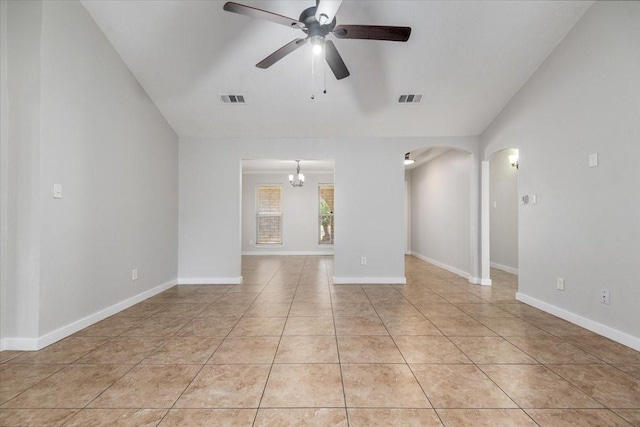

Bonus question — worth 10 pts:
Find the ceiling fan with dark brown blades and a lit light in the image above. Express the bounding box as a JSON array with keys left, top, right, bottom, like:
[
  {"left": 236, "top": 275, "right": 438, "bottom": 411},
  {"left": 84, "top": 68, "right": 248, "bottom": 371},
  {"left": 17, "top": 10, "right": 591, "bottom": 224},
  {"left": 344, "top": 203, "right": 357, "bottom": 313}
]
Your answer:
[{"left": 224, "top": 0, "right": 411, "bottom": 80}]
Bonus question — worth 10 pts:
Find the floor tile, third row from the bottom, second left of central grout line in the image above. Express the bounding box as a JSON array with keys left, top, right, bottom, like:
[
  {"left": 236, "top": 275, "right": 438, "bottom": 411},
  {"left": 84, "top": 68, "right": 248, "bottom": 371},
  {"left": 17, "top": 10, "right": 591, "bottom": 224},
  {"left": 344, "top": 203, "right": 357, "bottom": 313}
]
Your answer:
[{"left": 208, "top": 337, "right": 280, "bottom": 365}]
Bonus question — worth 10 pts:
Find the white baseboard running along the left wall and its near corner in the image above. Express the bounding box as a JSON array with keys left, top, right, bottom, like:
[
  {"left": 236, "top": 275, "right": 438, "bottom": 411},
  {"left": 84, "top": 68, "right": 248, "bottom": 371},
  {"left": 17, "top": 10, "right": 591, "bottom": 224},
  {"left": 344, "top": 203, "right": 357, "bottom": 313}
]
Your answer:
[{"left": 0, "top": 279, "right": 178, "bottom": 350}]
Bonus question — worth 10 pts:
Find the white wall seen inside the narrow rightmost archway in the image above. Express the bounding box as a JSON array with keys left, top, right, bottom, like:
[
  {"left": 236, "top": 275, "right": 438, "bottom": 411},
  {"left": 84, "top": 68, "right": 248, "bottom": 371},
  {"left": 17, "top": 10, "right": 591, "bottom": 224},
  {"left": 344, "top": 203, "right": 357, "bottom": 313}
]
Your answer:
[{"left": 489, "top": 149, "right": 519, "bottom": 274}]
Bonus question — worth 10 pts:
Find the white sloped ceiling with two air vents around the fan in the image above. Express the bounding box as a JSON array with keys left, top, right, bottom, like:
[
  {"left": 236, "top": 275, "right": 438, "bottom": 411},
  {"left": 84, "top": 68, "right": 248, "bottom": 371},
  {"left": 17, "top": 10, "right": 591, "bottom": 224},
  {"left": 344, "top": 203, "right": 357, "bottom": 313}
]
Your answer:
[{"left": 83, "top": 0, "right": 591, "bottom": 137}]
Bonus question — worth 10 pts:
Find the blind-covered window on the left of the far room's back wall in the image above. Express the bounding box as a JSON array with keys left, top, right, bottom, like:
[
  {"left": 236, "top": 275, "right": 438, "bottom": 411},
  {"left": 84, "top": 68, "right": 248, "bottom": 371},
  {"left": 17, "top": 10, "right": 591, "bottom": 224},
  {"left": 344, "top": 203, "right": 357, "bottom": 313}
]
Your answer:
[{"left": 256, "top": 185, "right": 282, "bottom": 245}]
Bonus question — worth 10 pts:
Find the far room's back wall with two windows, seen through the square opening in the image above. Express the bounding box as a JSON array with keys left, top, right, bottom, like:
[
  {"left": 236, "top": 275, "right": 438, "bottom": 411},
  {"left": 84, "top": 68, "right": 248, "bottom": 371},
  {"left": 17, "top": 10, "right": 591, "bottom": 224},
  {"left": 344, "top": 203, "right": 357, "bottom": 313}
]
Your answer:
[{"left": 242, "top": 173, "right": 338, "bottom": 254}]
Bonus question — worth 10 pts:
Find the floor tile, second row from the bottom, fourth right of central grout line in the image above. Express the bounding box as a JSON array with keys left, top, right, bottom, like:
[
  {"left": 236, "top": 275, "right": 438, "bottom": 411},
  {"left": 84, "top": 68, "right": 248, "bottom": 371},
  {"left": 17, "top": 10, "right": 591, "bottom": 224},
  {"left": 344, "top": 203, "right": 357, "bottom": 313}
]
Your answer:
[{"left": 550, "top": 365, "right": 640, "bottom": 409}]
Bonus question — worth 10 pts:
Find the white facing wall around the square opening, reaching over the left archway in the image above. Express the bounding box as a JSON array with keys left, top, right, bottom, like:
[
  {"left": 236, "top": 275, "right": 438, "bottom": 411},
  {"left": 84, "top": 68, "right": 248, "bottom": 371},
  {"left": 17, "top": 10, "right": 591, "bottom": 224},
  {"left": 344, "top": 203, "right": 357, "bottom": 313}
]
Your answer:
[{"left": 179, "top": 137, "right": 478, "bottom": 283}]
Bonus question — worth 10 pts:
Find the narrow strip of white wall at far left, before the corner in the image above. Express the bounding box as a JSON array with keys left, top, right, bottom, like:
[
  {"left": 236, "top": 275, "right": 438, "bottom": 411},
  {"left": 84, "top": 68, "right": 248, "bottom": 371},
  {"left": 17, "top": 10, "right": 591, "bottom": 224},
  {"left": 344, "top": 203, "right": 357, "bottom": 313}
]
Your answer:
[{"left": 0, "top": 2, "right": 42, "bottom": 348}]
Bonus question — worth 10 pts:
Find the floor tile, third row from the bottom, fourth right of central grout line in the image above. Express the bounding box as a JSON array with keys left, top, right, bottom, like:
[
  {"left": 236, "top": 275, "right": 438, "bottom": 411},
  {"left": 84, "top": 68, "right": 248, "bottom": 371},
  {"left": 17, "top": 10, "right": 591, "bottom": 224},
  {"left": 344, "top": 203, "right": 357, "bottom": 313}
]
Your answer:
[{"left": 507, "top": 337, "right": 602, "bottom": 364}]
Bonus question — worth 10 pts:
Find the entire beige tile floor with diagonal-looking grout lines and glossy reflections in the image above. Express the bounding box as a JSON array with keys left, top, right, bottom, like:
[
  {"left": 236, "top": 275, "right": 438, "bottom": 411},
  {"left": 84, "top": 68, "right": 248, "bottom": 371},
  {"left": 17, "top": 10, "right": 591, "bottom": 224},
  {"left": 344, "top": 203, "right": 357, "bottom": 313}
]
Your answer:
[{"left": 0, "top": 257, "right": 640, "bottom": 427}]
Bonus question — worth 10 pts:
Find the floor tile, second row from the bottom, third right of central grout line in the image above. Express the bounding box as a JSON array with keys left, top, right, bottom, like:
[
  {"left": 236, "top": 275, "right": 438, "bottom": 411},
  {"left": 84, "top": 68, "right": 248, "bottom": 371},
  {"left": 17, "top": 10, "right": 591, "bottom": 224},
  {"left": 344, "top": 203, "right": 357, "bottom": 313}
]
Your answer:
[{"left": 480, "top": 365, "right": 602, "bottom": 408}]
